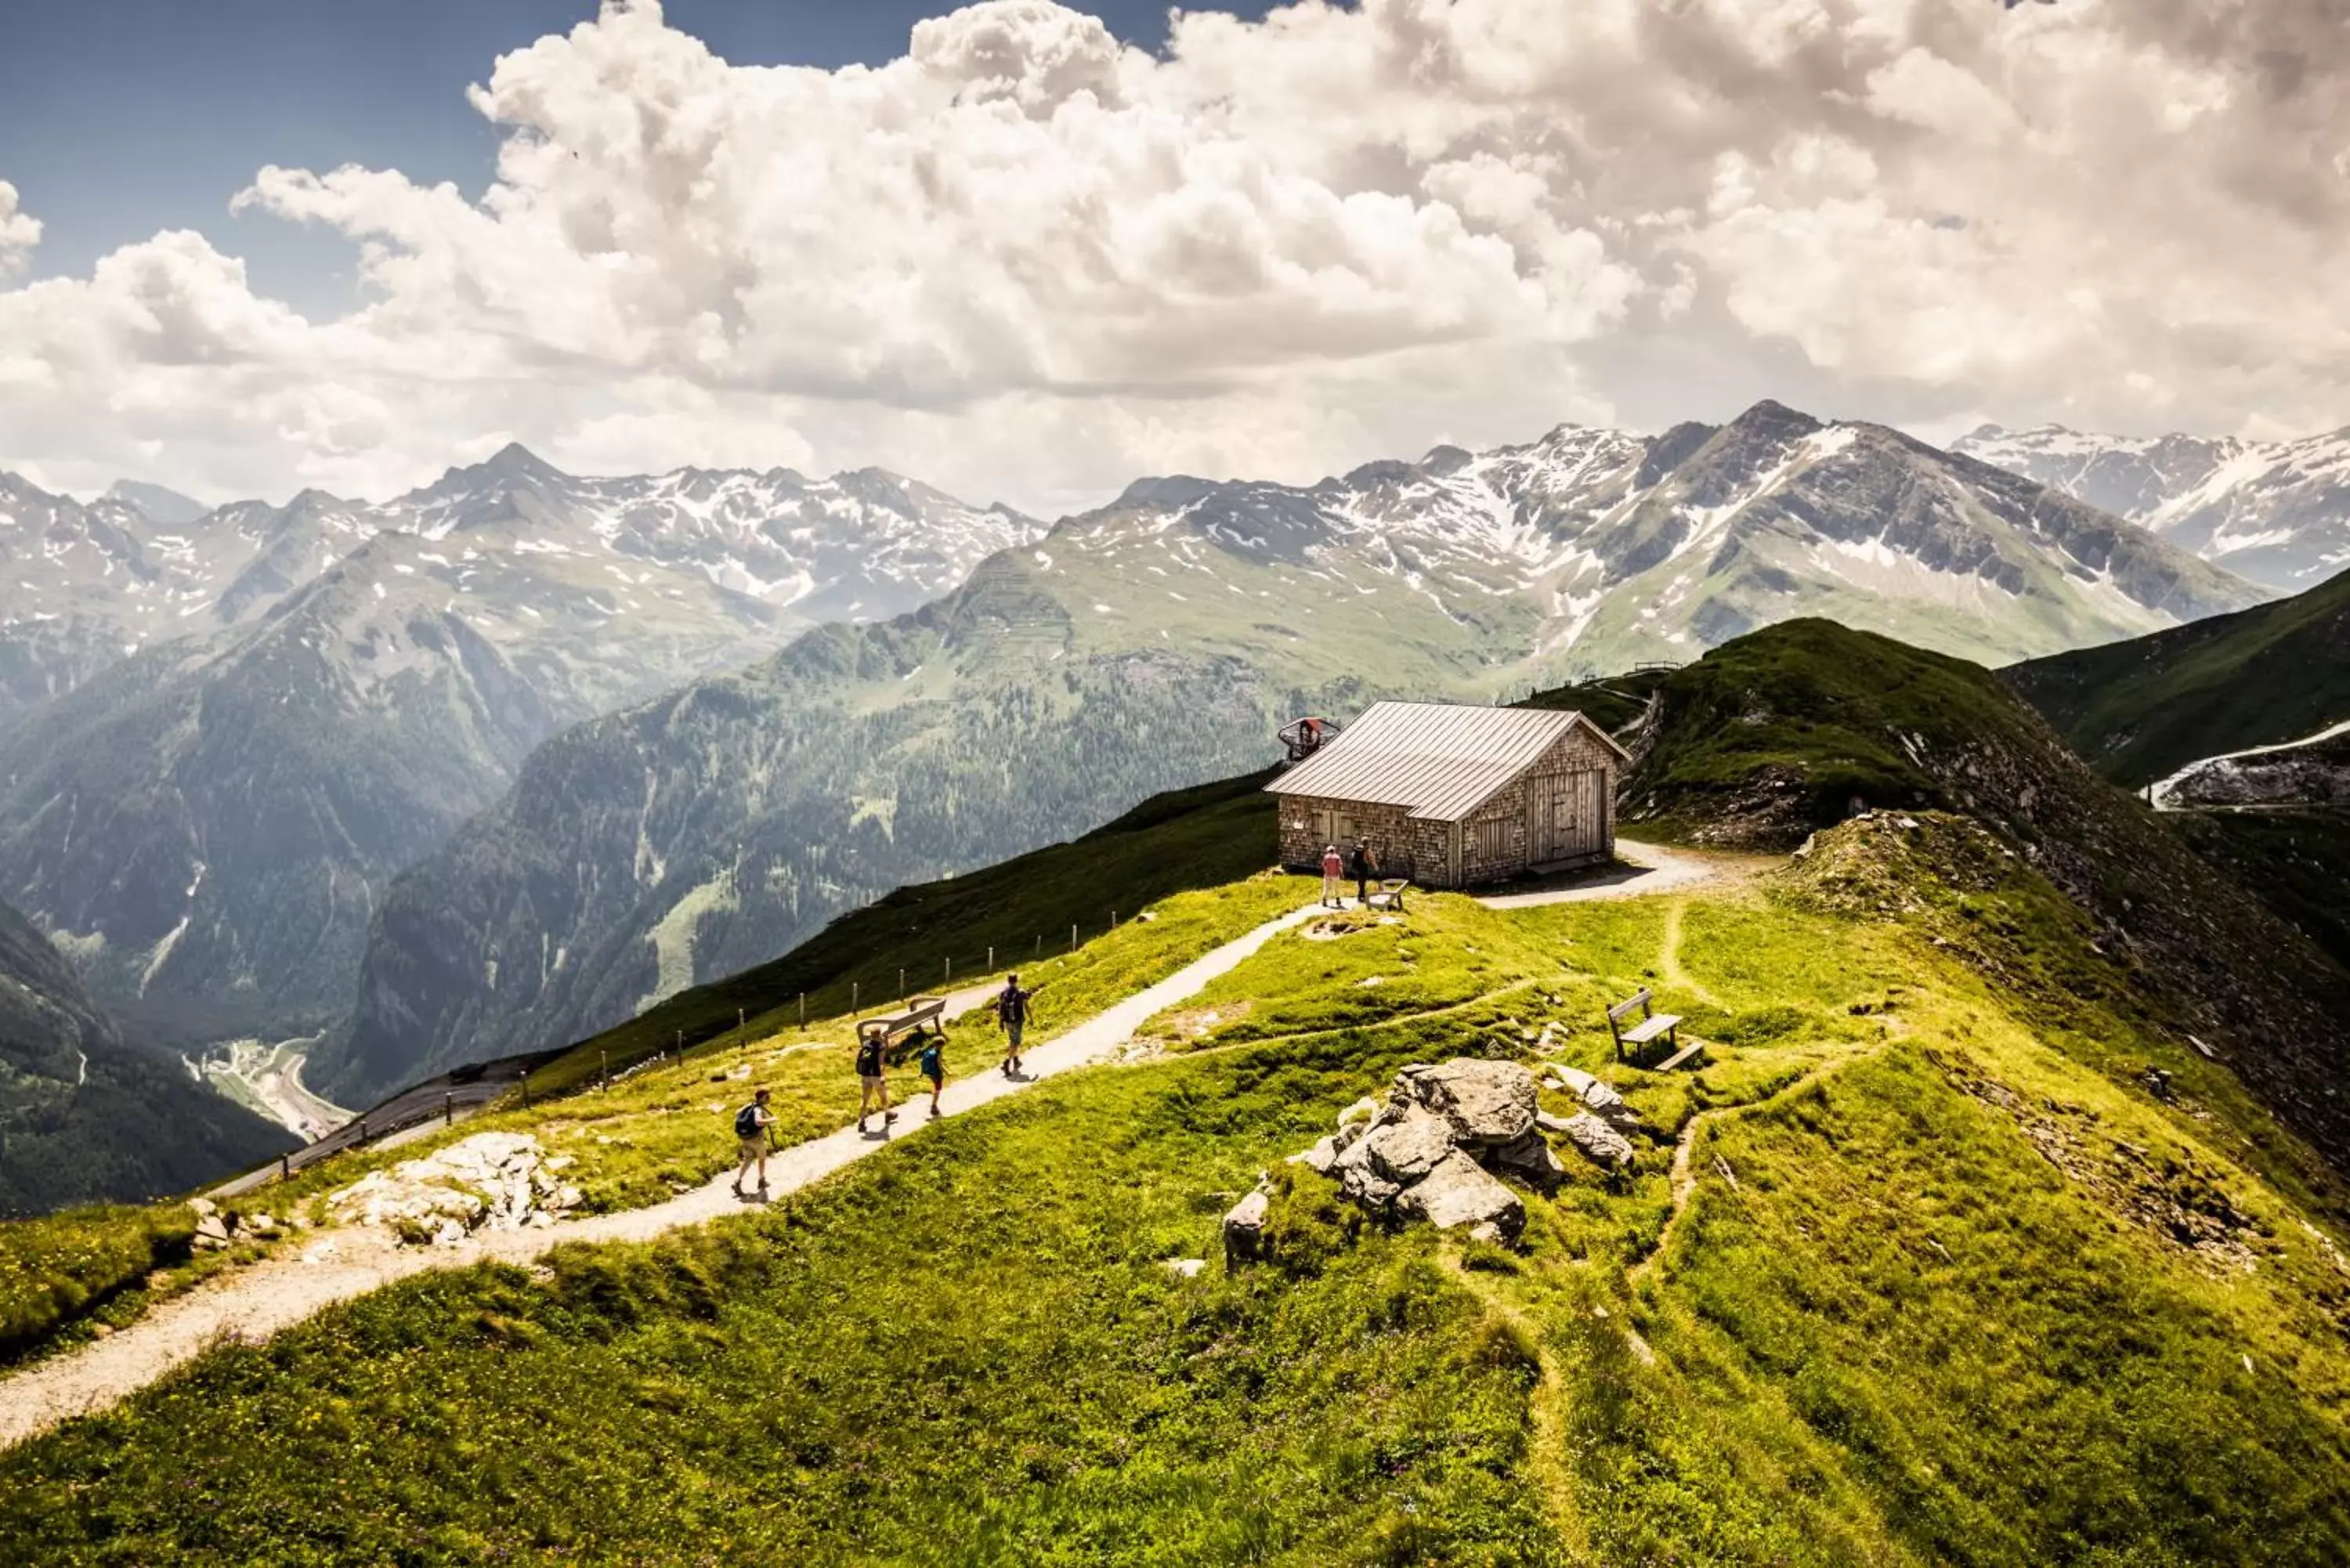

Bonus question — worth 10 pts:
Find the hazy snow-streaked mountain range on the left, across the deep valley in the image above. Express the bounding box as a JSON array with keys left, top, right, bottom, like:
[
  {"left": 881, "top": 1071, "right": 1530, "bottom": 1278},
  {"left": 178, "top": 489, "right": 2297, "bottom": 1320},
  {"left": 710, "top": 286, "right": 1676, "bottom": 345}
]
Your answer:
[{"left": 0, "top": 446, "right": 1041, "bottom": 1048}]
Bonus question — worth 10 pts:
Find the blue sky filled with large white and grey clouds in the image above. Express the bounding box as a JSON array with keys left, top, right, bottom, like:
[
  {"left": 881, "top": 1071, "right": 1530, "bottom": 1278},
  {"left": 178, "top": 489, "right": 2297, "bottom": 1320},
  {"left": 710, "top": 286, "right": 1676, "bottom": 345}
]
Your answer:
[{"left": 0, "top": 0, "right": 2350, "bottom": 515}]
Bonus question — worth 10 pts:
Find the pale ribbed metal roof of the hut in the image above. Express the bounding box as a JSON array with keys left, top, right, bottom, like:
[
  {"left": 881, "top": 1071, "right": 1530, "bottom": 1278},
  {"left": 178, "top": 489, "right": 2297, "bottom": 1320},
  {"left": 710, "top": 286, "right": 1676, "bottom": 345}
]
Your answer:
[{"left": 1264, "top": 703, "right": 1631, "bottom": 823}]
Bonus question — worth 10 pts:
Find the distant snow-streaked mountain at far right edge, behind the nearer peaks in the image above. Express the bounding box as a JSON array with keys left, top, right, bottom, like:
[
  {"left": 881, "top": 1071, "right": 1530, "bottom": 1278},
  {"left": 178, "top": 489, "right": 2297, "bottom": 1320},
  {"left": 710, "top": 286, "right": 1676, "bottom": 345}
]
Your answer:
[{"left": 1953, "top": 425, "right": 2350, "bottom": 592}]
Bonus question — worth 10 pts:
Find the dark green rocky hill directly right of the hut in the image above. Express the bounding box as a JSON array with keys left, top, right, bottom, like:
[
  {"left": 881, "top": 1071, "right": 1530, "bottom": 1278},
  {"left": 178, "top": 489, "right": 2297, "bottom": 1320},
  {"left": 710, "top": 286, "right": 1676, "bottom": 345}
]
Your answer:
[{"left": 1624, "top": 620, "right": 2350, "bottom": 1157}]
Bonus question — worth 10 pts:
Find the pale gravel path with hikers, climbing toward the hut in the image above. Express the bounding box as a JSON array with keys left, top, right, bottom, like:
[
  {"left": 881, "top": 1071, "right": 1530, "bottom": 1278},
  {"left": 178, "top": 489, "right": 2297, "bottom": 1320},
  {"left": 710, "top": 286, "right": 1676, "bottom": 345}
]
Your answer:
[{"left": 0, "top": 905, "right": 1318, "bottom": 1448}]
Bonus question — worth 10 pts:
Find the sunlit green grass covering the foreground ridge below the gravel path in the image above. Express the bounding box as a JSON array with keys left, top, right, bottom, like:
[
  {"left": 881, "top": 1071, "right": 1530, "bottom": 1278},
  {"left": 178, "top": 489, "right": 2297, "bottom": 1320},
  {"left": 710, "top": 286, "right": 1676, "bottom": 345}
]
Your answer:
[{"left": 18, "top": 818, "right": 2350, "bottom": 1566}]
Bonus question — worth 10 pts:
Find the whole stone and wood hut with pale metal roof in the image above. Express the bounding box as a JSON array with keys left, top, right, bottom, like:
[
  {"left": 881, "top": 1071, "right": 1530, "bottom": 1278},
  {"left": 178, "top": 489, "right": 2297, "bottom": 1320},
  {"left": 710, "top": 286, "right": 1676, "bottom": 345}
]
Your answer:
[{"left": 1267, "top": 703, "right": 1631, "bottom": 887}]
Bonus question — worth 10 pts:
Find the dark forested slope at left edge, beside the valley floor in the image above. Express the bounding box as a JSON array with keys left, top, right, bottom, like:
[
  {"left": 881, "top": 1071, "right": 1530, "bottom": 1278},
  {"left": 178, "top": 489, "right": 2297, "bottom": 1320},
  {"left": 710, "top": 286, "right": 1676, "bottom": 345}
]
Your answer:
[{"left": 0, "top": 905, "right": 294, "bottom": 1216}]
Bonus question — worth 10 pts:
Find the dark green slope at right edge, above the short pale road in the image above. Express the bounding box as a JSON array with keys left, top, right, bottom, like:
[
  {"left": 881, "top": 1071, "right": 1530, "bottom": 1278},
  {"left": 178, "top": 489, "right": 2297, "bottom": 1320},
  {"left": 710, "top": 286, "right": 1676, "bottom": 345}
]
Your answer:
[{"left": 2005, "top": 571, "right": 2350, "bottom": 786}]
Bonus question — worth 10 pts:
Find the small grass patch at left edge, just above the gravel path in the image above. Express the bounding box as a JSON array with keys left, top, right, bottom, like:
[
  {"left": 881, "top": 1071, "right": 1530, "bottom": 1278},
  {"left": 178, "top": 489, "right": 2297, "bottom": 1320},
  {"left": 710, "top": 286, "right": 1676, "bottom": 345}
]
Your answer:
[{"left": 0, "top": 1206, "right": 195, "bottom": 1361}]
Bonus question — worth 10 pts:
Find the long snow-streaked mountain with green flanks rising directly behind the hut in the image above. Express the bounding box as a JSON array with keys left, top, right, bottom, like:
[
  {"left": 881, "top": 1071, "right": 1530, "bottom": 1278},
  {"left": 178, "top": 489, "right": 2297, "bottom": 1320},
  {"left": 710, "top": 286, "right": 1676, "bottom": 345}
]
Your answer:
[{"left": 324, "top": 404, "right": 2261, "bottom": 1093}]
